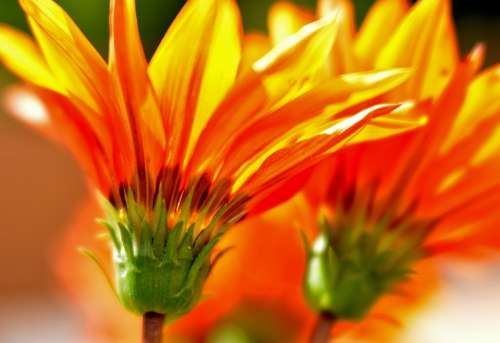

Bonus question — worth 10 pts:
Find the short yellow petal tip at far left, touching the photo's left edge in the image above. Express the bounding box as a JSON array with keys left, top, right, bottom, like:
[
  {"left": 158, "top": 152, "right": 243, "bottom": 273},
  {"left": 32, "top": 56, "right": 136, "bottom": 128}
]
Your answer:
[{"left": 0, "top": 25, "right": 63, "bottom": 93}]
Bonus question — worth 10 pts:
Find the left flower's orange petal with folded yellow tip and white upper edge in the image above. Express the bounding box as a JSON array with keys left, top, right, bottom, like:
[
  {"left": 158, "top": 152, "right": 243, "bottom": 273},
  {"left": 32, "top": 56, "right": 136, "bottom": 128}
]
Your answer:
[{"left": 190, "top": 16, "right": 336, "bottom": 175}]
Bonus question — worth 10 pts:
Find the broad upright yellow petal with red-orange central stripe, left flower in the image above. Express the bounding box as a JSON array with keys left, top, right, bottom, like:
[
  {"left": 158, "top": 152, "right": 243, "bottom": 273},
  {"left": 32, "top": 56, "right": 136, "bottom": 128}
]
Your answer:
[{"left": 149, "top": 0, "right": 241, "bottom": 168}]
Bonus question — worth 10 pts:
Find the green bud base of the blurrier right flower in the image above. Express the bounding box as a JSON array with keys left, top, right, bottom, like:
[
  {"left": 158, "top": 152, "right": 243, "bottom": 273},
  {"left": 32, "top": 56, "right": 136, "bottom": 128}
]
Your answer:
[{"left": 304, "top": 210, "right": 427, "bottom": 320}]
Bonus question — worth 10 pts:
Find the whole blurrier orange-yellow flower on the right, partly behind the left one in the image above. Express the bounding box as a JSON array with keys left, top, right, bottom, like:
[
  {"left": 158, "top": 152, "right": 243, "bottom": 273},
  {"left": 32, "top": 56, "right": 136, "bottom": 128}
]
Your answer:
[{"left": 262, "top": 0, "right": 500, "bottom": 341}]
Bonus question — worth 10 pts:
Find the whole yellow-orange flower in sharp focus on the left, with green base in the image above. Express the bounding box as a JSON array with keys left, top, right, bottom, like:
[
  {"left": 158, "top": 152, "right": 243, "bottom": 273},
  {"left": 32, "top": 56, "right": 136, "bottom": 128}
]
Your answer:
[{"left": 0, "top": 0, "right": 418, "bottom": 339}]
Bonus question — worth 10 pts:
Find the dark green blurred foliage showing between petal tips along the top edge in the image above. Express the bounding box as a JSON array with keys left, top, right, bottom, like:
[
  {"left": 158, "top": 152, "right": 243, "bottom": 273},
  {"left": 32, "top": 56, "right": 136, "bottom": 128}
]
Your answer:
[{"left": 0, "top": 0, "right": 500, "bottom": 59}]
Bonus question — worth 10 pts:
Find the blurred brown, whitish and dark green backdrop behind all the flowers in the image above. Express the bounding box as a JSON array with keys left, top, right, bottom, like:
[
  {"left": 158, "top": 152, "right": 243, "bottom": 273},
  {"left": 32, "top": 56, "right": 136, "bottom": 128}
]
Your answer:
[{"left": 0, "top": 0, "right": 500, "bottom": 343}]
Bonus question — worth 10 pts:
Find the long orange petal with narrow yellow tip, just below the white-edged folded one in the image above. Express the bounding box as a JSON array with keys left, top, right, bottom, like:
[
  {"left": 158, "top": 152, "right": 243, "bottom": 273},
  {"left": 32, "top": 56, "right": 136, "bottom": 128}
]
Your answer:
[{"left": 221, "top": 70, "right": 407, "bottom": 176}]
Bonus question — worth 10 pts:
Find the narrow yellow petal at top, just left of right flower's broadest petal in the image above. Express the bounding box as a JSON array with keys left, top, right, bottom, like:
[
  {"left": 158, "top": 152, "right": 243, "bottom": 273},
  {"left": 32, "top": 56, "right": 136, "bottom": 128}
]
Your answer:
[{"left": 355, "top": 0, "right": 408, "bottom": 69}]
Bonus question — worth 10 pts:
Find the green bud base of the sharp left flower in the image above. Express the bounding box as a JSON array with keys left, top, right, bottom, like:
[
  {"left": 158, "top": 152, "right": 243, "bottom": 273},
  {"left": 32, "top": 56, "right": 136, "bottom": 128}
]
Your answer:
[{"left": 101, "top": 188, "right": 230, "bottom": 320}]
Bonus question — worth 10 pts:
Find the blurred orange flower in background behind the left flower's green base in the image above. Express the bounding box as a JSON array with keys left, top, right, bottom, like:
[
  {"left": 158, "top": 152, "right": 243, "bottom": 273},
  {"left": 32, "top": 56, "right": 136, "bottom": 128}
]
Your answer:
[{"left": 56, "top": 200, "right": 314, "bottom": 343}]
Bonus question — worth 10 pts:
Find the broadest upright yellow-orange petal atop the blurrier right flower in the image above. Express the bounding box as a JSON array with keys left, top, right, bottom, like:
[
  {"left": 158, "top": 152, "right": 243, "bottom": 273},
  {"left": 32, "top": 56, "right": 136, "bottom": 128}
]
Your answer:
[{"left": 375, "top": 0, "right": 458, "bottom": 99}]
